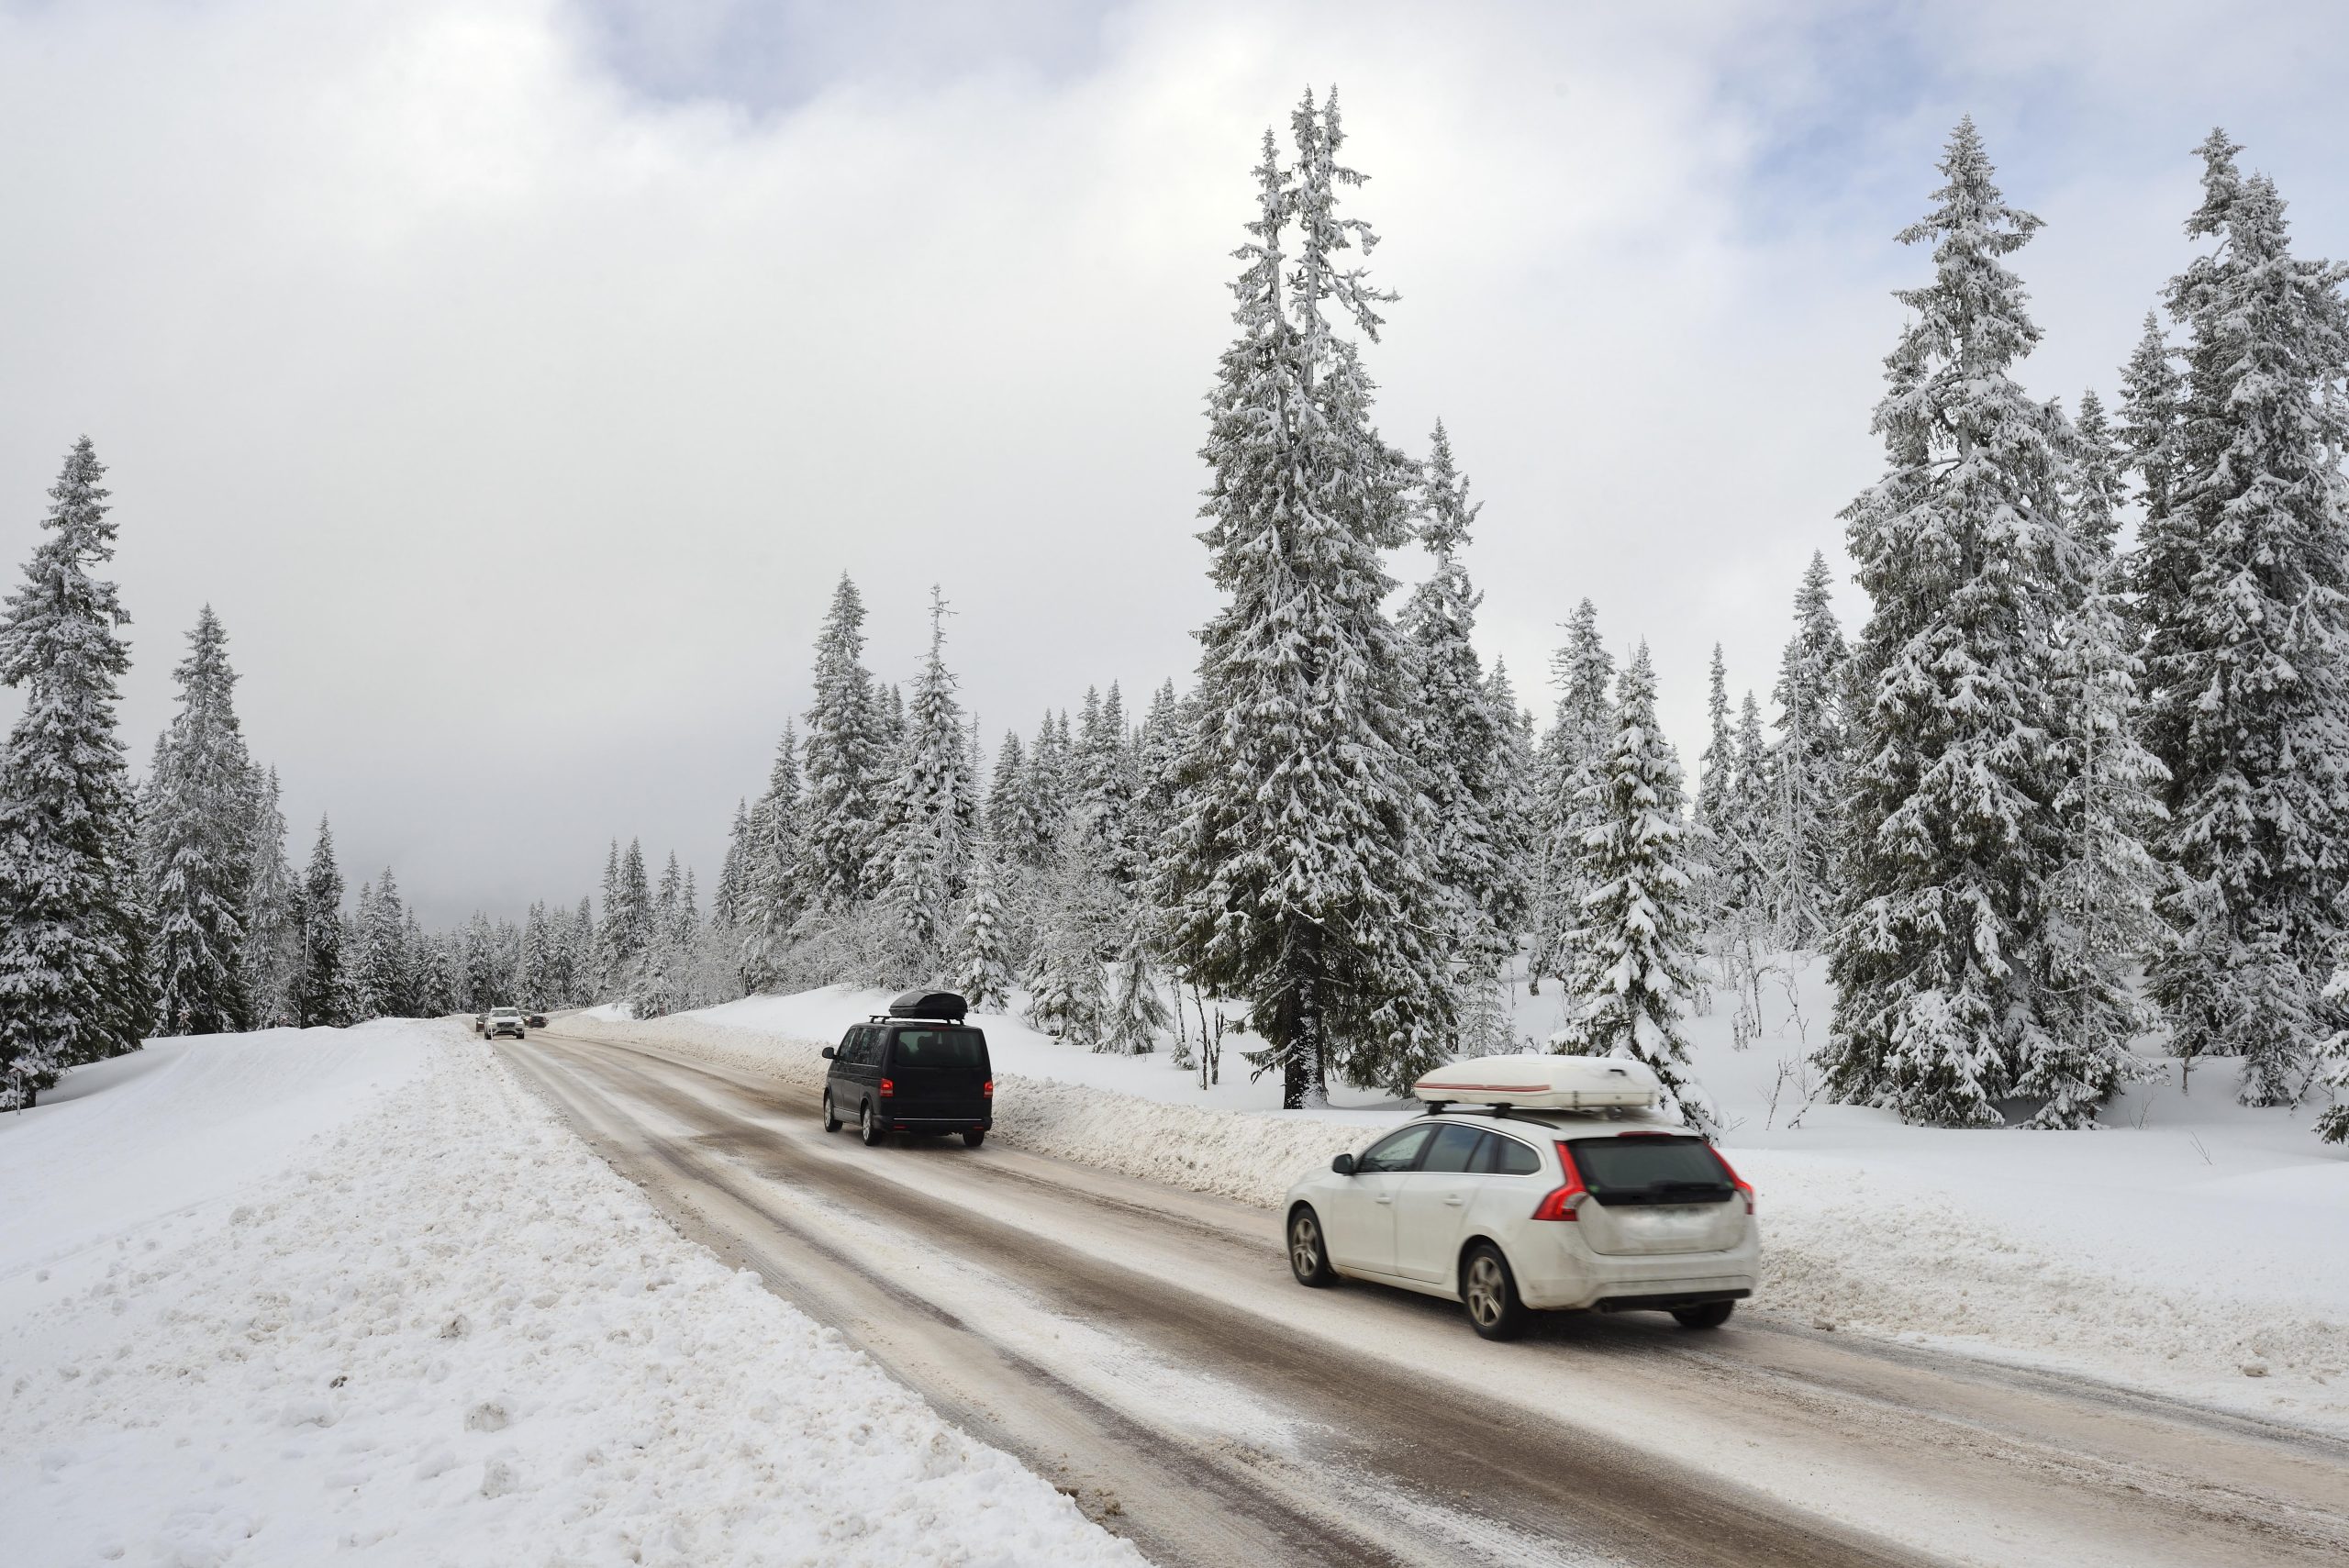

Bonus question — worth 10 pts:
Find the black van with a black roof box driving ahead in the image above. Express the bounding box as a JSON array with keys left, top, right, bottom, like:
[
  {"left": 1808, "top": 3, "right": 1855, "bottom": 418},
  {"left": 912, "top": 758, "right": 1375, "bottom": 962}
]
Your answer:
[{"left": 825, "top": 991, "right": 996, "bottom": 1148}]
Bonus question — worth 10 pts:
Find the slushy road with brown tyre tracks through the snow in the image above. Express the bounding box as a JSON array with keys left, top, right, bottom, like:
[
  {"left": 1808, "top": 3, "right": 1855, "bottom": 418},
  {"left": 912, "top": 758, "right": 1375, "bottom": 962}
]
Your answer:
[{"left": 498, "top": 1030, "right": 2349, "bottom": 1565}]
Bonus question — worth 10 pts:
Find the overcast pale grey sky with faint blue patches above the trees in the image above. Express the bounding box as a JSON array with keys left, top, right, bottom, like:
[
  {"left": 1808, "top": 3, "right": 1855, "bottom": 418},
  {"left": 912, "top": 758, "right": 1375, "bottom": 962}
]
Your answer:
[{"left": 0, "top": 0, "right": 2349, "bottom": 922}]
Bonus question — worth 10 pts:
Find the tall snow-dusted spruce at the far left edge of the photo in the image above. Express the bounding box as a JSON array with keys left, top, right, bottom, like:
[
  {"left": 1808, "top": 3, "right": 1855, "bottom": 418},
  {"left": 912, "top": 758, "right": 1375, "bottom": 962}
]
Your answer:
[{"left": 0, "top": 437, "right": 155, "bottom": 1108}]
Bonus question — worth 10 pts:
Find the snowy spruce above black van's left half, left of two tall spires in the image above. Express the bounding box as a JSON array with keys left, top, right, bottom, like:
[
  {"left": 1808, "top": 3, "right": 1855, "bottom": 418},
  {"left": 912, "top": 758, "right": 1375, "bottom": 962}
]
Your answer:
[{"left": 804, "top": 573, "right": 890, "bottom": 911}]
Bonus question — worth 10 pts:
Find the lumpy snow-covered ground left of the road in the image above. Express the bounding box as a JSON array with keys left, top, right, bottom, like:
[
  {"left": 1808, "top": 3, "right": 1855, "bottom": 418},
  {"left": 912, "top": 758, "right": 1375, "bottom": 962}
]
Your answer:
[{"left": 0, "top": 1023, "right": 1140, "bottom": 1568}]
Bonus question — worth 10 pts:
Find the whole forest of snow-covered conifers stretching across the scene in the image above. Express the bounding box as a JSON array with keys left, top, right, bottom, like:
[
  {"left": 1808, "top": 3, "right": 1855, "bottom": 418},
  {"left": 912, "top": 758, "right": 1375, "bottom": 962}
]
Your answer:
[{"left": 0, "top": 94, "right": 2349, "bottom": 1139}]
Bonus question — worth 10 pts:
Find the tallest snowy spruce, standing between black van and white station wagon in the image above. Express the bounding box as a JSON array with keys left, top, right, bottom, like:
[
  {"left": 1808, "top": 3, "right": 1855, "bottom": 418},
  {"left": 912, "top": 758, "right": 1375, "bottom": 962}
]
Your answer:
[{"left": 1161, "top": 94, "right": 1456, "bottom": 1106}]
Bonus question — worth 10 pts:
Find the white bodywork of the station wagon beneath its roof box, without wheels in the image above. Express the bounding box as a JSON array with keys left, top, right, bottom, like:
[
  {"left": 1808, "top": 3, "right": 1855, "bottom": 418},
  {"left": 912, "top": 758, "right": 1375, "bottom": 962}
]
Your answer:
[{"left": 1283, "top": 1108, "right": 1762, "bottom": 1317}]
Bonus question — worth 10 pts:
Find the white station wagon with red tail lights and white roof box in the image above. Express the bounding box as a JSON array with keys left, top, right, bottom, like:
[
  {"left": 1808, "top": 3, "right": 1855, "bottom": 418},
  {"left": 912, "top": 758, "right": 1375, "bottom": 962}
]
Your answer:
[{"left": 1285, "top": 1056, "right": 1762, "bottom": 1340}]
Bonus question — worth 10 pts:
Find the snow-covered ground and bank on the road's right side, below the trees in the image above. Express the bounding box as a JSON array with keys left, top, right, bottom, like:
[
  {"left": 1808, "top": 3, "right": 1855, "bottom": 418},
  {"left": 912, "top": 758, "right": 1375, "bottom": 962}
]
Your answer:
[{"left": 584, "top": 964, "right": 2349, "bottom": 1432}]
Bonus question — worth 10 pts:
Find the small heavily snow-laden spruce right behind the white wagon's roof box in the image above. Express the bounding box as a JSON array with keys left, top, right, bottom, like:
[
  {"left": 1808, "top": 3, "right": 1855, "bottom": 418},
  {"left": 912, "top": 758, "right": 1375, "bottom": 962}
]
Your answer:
[{"left": 1557, "top": 643, "right": 1712, "bottom": 1131}]
